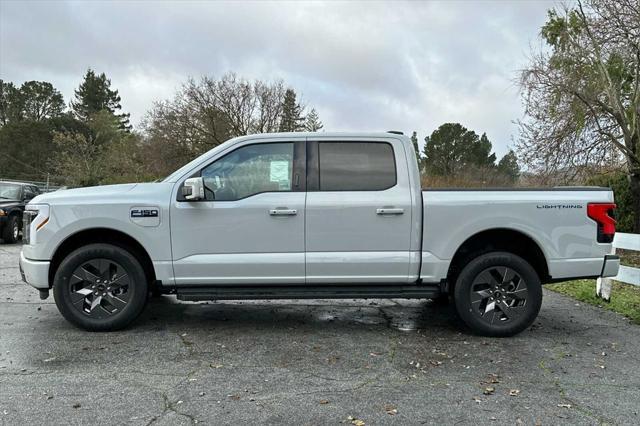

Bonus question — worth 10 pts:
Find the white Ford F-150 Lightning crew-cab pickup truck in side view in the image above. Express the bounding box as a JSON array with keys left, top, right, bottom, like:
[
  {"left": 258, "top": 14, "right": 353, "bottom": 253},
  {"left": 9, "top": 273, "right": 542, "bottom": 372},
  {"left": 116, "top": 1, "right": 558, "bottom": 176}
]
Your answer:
[{"left": 20, "top": 132, "right": 619, "bottom": 336}]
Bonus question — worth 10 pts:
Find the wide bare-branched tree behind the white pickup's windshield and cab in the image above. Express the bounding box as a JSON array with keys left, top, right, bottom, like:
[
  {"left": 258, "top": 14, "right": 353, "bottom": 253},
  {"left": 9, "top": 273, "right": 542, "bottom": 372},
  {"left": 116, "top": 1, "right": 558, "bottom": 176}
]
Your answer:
[{"left": 143, "top": 73, "right": 292, "bottom": 174}]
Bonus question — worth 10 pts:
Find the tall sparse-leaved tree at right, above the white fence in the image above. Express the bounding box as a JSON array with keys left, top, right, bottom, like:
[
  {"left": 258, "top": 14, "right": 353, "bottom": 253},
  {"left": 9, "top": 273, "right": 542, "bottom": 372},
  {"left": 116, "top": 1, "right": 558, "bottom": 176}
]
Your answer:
[{"left": 516, "top": 0, "right": 640, "bottom": 232}]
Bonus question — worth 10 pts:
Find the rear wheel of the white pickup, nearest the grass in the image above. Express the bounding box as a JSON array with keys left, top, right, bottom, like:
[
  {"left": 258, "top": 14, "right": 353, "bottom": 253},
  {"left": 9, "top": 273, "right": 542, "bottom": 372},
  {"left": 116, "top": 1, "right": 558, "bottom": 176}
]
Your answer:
[{"left": 454, "top": 252, "right": 542, "bottom": 337}]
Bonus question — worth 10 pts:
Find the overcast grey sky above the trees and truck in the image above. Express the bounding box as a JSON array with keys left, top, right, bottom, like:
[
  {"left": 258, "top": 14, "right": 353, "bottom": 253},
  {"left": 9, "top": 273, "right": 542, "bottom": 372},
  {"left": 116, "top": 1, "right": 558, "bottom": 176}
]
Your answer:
[{"left": 0, "top": 0, "right": 554, "bottom": 155}]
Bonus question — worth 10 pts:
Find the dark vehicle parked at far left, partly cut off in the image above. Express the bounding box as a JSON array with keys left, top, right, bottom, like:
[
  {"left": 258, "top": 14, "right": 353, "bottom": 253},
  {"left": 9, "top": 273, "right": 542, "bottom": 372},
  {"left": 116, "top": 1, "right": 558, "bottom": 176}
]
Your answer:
[{"left": 0, "top": 181, "right": 40, "bottom": 243}]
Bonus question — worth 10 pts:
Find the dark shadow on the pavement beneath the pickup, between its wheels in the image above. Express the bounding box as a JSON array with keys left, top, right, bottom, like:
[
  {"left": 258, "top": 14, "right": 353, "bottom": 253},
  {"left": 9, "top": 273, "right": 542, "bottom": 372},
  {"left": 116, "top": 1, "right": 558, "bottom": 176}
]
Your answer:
[{"left": 137, "top": 296, "right": 463, "bottom": 333}]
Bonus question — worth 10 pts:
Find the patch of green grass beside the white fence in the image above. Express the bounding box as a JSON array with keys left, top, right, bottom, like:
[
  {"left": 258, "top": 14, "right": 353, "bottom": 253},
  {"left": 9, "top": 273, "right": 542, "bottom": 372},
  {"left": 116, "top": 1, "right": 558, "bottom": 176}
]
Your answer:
[{"left": 545, "top": 280, "right": 640, "bottom": 324}]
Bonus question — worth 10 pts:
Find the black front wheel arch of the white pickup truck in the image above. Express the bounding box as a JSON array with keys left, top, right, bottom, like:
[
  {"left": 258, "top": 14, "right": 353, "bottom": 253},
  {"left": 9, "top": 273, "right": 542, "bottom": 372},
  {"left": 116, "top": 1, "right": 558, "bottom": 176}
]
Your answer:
[{"left": 49, "top": 228, "right": 156, "bottom": 288}]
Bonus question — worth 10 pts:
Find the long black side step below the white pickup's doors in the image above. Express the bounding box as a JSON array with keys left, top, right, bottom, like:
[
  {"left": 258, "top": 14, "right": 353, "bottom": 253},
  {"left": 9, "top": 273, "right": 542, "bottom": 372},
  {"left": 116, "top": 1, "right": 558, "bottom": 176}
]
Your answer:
[{"left": 175, "top": 285, "right": 441, "bottom": 301}]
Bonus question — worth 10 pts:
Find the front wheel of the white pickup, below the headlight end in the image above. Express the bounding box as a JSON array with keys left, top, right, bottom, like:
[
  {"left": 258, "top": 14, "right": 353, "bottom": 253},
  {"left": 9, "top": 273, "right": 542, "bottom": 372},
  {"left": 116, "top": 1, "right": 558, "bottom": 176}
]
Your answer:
[{"left": 53, "top": 244, "right": 149, "bottom": 331}]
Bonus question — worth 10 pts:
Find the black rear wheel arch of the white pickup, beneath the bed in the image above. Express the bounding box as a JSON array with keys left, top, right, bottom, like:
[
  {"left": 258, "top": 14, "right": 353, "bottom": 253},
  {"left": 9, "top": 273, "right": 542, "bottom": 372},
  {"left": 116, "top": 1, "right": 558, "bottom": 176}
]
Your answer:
[{"left": 447, "top": 228, "right": 551, "bottom": 287}]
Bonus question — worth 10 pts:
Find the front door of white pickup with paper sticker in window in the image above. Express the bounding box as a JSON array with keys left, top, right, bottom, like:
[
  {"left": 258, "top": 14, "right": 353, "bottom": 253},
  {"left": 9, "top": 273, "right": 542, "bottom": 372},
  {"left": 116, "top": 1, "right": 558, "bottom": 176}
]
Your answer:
[{"left": 171, "top": 139, "right": 305, "bottom": 286}]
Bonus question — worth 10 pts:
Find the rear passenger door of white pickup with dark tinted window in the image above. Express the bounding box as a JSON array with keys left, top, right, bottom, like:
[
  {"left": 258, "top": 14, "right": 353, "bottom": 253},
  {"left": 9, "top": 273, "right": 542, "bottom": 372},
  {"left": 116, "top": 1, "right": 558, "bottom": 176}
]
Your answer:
[{"left": 305, "top": 138, "right": 412, "bottom": 283}]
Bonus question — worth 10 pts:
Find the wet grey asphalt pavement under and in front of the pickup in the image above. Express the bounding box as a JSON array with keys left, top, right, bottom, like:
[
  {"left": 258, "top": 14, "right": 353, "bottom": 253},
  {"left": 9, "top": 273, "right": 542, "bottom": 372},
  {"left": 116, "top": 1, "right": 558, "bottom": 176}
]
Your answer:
[{"left": 0, "top": 241, "right": 640, "bottom": 425}]
